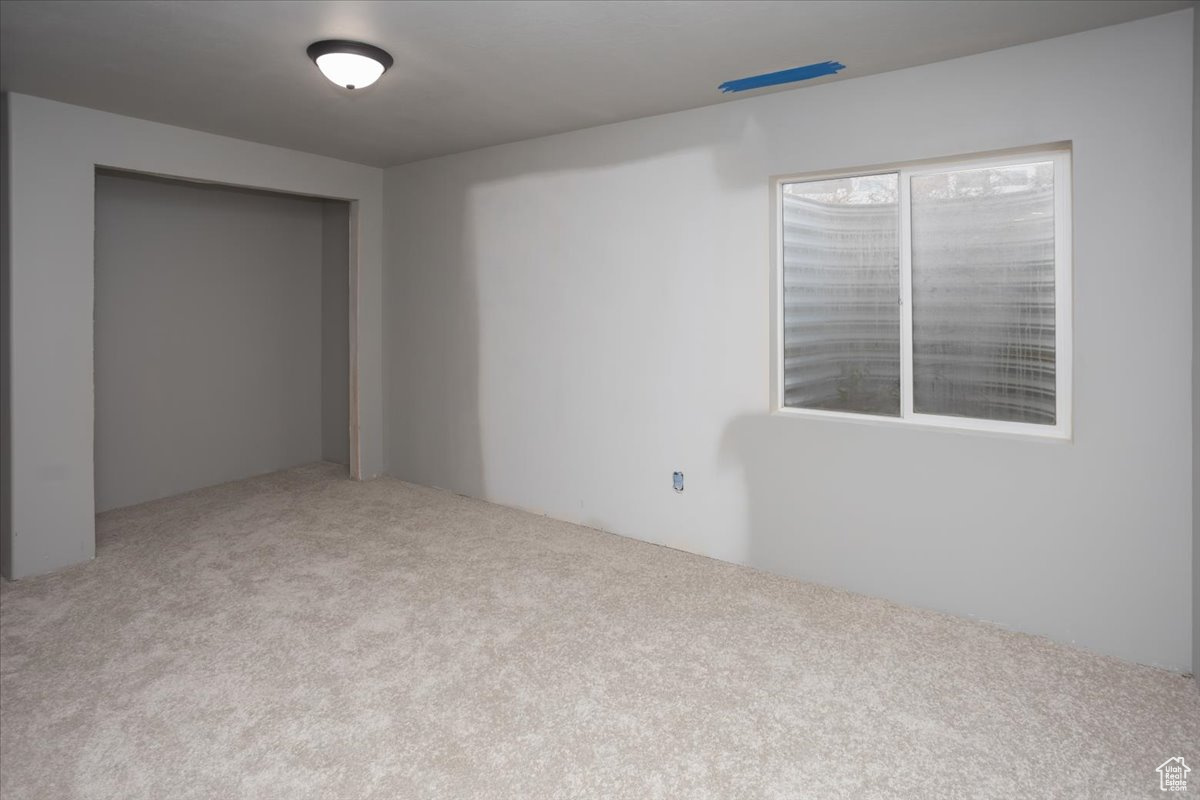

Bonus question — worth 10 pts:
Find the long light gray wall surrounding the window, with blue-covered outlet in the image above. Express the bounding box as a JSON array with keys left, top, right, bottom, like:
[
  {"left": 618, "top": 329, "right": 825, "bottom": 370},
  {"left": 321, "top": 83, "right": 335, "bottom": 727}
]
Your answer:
[{"left": 385, "top": 10, "right": 1193, "bottom": 669}]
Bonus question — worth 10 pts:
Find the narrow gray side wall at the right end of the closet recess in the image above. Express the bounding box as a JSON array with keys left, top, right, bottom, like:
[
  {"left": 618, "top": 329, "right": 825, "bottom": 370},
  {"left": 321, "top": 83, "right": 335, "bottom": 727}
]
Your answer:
[{"left": 320, "top": 200, "right": 350, "bottom": 465}]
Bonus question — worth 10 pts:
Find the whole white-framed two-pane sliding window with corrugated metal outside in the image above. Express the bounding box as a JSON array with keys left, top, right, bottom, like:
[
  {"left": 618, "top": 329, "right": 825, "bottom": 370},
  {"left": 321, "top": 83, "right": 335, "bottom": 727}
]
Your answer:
[{"left": 774, "top": 149, "right": 1070, "bottom": 438}]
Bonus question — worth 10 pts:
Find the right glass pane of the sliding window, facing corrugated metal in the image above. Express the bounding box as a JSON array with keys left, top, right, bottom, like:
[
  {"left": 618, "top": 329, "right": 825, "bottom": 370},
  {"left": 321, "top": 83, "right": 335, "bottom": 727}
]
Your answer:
[{"left": 911, "top": 162, "right": 1055, "bottom": 425}]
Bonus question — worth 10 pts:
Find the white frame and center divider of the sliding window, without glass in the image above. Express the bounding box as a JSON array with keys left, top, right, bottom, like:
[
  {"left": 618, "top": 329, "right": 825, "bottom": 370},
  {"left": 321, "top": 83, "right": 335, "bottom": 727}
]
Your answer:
[{"left": 770, "top": 143, "right": 1073, "bottom": 441}]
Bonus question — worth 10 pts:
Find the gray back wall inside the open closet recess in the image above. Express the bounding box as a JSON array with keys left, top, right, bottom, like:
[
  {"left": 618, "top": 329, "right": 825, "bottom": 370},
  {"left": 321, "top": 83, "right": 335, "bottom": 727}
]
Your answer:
[{"left": 95, "top": 173, "right": 346, "bottom": 511}]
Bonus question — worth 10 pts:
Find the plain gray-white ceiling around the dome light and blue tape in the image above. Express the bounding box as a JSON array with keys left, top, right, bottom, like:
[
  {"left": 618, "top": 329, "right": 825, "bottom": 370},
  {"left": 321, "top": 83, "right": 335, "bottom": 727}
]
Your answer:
[{"left": 0, "top": 0, "right": 1192, "bottom": 166}]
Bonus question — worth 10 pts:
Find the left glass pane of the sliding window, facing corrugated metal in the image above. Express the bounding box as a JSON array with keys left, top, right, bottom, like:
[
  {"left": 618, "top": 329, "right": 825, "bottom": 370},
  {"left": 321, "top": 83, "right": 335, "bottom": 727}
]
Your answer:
[{"left": 782, "top": 173, "right": 900, "bottom": 416}]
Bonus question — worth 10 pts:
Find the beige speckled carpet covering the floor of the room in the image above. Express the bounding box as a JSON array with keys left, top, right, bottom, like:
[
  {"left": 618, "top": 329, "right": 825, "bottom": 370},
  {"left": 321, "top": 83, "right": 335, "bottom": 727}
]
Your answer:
[{"left": 0, "top": 465, "right": 1200, "bottom": 800}]
